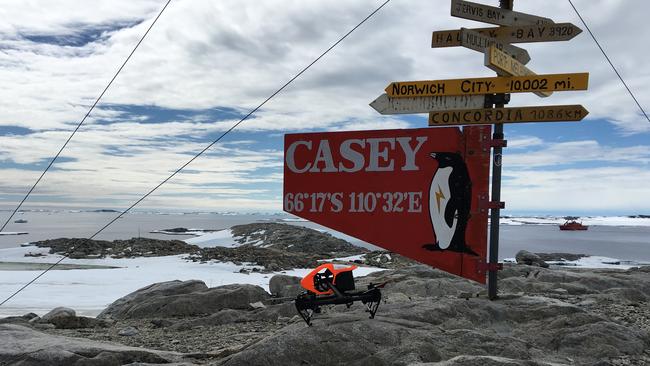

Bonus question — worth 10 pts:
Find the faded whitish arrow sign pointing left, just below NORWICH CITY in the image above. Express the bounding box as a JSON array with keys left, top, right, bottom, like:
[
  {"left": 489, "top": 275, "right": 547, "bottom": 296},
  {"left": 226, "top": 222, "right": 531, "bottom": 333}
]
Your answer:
[{"left": 370, "top": 94, "right": 485, "bottom": 114}]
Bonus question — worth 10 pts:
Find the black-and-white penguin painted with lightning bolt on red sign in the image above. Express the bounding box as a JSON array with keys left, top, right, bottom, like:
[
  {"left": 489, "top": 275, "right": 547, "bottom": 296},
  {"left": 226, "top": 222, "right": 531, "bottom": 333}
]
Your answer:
[{"left": 422, "top": 152, "right": 477, "bottom": 255}]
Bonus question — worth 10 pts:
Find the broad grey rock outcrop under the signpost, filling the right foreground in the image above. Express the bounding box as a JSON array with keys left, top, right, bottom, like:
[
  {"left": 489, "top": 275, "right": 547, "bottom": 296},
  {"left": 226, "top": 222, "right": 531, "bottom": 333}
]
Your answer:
[{"left": 222, "top": 265, "right": 650, "bottom": 366}]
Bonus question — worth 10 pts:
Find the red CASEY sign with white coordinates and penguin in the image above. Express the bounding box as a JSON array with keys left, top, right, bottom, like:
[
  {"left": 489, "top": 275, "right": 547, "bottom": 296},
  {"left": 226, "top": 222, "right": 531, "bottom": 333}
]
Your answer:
[{"left": 284, "top": 126, "right": 491, "bottom": 283}]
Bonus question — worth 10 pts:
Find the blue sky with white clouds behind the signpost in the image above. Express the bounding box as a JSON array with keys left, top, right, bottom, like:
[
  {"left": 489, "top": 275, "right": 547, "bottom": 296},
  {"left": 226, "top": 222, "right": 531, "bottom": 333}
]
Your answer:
[{"left": 0, "top": 0, "right": 650, "bottom": 215}]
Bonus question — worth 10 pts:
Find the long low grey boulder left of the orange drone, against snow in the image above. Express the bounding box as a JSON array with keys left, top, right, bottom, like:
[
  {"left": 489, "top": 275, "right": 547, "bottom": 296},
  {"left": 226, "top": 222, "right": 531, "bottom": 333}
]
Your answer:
[{"left": 97, "top": 280, "right": 269, "bottom": 320}]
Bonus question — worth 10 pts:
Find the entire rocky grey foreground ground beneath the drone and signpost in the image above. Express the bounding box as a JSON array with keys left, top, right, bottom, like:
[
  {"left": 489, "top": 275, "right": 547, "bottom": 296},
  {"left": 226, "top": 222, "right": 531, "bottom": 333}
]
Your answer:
[{"left": 0, "top": 264, "right": 650, "bottom": 366}]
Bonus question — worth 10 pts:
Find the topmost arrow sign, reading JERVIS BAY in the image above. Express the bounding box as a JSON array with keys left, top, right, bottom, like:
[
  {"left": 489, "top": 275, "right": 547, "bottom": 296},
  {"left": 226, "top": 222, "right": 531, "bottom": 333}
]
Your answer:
[{"left": 451, "top": 0, "right": 553, "bottom": 26}]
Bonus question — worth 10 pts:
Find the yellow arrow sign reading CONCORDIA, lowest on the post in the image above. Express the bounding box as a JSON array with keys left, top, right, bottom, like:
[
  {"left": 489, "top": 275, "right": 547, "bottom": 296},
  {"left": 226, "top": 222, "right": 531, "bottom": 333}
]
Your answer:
[{"left": 429, "top": 105, "right": 589, "bottom": 126}]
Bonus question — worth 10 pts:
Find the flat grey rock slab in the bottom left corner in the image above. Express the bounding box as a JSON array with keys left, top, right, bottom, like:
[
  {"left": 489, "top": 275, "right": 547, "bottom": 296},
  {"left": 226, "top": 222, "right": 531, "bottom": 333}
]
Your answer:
[{"left": 0, "top": 324, "right": 190, "bottom": 366}]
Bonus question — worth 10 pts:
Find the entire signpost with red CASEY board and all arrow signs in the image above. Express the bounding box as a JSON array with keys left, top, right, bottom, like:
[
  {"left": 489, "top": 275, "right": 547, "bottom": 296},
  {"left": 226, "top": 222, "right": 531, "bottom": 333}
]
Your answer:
[{"left": 284, "top": 0, "right": 589, "bottom": 299}]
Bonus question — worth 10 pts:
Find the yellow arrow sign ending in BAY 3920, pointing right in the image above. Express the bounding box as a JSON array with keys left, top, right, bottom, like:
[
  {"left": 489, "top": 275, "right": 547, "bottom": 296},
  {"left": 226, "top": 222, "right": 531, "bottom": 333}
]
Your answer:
[{"left": 431, "top": 23, "right": 582, "bottom": 48}]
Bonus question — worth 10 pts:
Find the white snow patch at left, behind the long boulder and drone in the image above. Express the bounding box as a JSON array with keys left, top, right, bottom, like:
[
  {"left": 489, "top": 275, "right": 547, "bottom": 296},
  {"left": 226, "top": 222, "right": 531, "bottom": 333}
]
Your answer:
[{"left": 0, "top": 246, "right": 383, "bottom": 317}]
